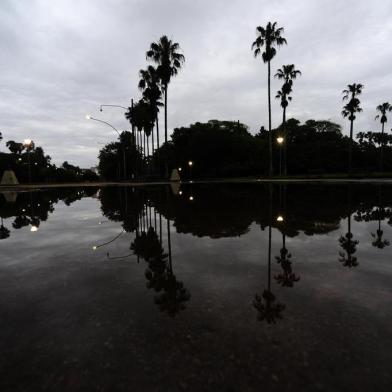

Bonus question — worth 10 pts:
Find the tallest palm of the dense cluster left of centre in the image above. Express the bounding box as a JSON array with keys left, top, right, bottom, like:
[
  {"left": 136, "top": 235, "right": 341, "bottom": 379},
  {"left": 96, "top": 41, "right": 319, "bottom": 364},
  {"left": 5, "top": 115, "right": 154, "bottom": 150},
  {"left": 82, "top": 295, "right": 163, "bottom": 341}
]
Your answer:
[{"left": 146, "top": 35, "right": 185, "bottom": 143}]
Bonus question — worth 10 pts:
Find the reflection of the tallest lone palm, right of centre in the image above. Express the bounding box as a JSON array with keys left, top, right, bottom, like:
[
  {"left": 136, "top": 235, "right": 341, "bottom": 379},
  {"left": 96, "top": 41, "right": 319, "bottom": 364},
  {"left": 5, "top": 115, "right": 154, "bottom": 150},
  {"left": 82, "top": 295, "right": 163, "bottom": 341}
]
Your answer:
[{"left": 253, "top": 185, "right": 285, "bottom": 324}]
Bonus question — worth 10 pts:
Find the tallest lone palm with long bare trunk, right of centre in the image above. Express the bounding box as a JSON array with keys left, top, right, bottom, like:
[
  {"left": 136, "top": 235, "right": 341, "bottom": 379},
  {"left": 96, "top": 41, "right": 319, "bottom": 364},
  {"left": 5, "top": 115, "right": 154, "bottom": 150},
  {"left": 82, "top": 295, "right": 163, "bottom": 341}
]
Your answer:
[{"left": 252, "top": 22, "right": 287, "bottom": 176}]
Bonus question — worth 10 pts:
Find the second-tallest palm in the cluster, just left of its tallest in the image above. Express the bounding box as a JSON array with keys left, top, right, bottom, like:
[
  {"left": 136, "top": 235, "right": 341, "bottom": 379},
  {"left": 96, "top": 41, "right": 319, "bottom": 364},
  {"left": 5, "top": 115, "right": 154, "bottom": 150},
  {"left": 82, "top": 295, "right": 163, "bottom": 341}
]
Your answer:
[{"left": 138, "top": 65, "right": 163, "bottom": 154}]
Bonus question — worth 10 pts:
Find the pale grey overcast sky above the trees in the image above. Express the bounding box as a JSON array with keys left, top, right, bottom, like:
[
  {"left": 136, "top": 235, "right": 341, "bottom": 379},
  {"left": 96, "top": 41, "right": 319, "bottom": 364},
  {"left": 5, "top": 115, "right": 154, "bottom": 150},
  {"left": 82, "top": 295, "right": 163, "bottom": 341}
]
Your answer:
[{"left": 0, "top": 0, "right": 392, "bottom": 168}]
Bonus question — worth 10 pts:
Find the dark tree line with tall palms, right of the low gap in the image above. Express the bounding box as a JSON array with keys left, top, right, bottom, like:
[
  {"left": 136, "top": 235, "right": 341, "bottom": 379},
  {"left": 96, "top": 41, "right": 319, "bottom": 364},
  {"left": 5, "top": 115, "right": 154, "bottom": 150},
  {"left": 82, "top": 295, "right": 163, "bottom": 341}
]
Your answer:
[{"left": 102, "top": 22, "right": 392, "bottom": 177}]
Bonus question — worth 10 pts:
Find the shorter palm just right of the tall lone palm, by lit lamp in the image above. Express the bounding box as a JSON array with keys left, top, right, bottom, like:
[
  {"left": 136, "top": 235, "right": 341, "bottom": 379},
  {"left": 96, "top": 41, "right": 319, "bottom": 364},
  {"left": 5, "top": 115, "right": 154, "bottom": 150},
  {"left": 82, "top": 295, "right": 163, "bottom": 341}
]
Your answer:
[{"left": 275, "top": 64, "right": 302, "bottom": 175}]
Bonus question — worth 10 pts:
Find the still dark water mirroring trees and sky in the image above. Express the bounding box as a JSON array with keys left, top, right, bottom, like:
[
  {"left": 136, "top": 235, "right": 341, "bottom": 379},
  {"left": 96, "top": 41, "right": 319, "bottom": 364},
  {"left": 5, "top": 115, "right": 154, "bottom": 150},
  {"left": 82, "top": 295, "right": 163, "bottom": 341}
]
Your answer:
[{"left": 0, "top": 183, "right": 392, "bottom": 391}]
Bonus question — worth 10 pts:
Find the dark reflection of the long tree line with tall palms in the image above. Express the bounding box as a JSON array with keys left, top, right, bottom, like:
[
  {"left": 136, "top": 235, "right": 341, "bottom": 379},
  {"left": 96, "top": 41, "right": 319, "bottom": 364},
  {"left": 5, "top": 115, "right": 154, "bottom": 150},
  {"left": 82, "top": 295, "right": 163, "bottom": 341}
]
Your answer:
[{"left": 101, "top": 185, "right": 391, "bottom": 323}]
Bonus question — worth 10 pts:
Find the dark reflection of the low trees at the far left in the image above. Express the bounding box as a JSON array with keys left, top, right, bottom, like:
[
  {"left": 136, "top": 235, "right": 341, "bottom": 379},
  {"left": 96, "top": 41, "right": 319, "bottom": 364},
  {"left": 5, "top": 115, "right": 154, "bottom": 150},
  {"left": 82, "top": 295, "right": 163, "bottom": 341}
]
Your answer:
[{"left": 0, "top": 188, "right": 97, "bottom": 239}]
